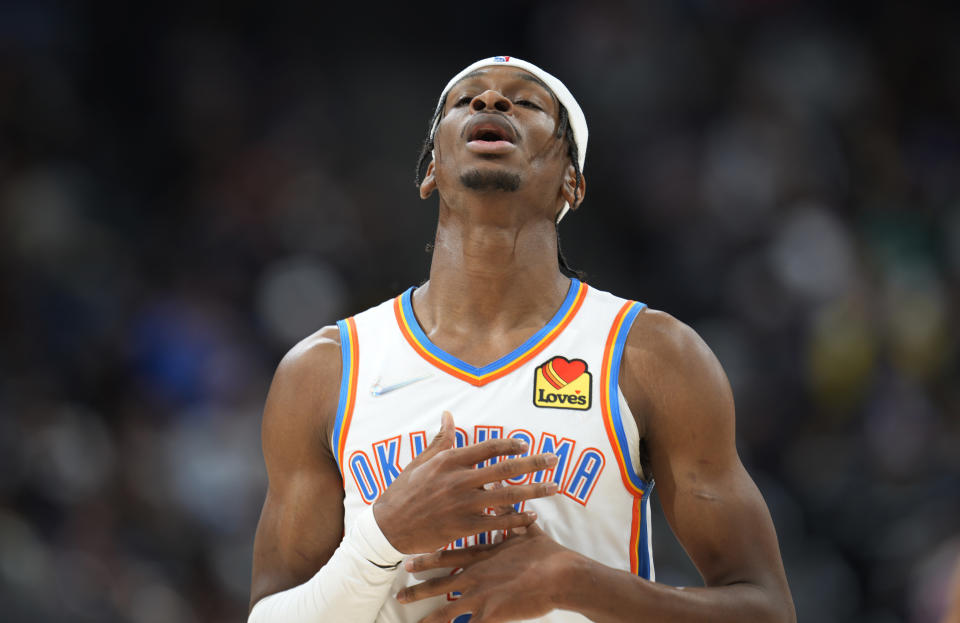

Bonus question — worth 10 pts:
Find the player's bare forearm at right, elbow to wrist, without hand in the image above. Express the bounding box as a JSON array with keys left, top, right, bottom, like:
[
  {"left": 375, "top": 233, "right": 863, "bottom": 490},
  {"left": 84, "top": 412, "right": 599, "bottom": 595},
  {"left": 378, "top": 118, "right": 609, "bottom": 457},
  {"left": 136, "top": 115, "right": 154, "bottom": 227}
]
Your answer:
[{"left": 558, "top": 556, "right": 796, "bottom": 623}]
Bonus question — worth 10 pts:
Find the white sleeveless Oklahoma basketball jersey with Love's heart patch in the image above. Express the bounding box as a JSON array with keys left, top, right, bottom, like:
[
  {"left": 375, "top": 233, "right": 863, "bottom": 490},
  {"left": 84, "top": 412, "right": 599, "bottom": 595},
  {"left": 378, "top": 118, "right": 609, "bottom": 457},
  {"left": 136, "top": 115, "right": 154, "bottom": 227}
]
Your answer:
[{"left": 332, "top": 279, "right": 653, "bottom": 623}]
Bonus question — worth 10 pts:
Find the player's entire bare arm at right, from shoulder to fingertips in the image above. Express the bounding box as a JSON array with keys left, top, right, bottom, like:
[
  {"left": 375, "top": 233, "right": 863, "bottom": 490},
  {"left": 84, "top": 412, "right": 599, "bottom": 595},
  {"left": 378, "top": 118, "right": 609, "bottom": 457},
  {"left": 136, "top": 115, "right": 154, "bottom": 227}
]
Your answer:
[{"left": 399, "top": 312, "right": 796, "bottom": 623}]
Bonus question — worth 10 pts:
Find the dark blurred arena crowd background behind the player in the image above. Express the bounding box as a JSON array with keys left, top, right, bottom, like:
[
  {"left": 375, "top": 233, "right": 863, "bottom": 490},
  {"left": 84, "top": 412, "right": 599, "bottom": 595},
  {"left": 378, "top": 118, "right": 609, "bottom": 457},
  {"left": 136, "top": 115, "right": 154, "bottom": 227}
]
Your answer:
[{"left": 0, "top": 0, "right": 960, "bottom": 623}]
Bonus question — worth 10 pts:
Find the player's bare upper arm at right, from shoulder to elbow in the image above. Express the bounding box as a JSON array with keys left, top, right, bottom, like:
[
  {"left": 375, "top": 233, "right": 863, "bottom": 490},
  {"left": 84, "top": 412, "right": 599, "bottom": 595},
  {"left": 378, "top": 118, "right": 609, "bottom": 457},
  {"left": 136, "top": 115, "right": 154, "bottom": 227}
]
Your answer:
[{"left": 625, "top": 317, "right": 785, "bottom": 586}]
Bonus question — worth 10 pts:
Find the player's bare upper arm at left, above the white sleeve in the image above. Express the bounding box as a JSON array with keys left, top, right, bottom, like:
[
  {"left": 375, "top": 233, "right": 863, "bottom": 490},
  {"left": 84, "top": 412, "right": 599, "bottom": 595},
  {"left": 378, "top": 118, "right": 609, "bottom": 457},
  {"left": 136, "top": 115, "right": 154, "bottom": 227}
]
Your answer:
[{"left": 250, "top": 330, "right": 343, "bottom": 606}]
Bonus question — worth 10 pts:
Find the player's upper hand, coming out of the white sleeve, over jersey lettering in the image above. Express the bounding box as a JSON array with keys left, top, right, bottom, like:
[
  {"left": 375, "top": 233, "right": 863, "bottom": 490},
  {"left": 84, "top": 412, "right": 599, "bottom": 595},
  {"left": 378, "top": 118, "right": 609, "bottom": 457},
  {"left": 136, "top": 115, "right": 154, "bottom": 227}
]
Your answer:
[{"left": 373, "top": 411, "right": 557, "bottom": 554}]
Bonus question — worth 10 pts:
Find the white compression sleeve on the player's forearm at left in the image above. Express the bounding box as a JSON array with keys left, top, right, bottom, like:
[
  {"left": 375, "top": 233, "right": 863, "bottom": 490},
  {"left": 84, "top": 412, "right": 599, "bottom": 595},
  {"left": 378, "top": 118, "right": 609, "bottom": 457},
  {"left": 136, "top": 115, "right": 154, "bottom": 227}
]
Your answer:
[{"left": 247, "top": 506, "right": 403, "bottom": 623}]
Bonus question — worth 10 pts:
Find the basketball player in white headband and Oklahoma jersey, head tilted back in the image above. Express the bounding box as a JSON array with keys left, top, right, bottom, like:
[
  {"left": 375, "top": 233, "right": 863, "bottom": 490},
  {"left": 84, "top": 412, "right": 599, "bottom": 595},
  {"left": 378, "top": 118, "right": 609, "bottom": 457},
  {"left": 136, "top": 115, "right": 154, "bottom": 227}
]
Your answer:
[{"left": 250, "top": 57, "right": 795, "bottom": 623}]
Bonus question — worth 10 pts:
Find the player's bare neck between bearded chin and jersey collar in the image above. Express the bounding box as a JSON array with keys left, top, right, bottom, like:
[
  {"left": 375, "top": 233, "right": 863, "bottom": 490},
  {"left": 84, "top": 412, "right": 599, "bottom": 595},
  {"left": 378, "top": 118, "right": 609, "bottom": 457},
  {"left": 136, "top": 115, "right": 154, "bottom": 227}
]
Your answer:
[{"left": 414, "top": 193, "right": 570, "bottom": 342}]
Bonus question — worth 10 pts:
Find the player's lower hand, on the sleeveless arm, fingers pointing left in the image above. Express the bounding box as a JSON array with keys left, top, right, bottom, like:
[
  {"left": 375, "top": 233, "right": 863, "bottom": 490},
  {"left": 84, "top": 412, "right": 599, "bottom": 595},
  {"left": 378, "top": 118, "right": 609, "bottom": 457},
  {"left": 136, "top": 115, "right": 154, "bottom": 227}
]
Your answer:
[{"left": 397, "top": 524, "right": 578, "bottom": 623}]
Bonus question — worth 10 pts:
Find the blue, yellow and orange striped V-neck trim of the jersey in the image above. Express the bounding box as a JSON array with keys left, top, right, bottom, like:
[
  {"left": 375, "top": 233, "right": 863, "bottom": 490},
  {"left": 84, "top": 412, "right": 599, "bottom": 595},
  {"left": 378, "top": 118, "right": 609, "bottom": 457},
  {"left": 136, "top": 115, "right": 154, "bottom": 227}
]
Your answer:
[{"left": 393, "top": 278, "right": 589, "bottom": 387}]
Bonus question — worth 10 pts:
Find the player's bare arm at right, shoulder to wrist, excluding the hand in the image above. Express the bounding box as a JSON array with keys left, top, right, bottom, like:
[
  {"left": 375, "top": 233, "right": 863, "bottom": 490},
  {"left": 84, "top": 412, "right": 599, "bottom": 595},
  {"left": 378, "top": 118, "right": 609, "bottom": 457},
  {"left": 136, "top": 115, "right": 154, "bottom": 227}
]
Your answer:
[{"left": 570, "top": 312, "right": 796, "bottom": 623}]
